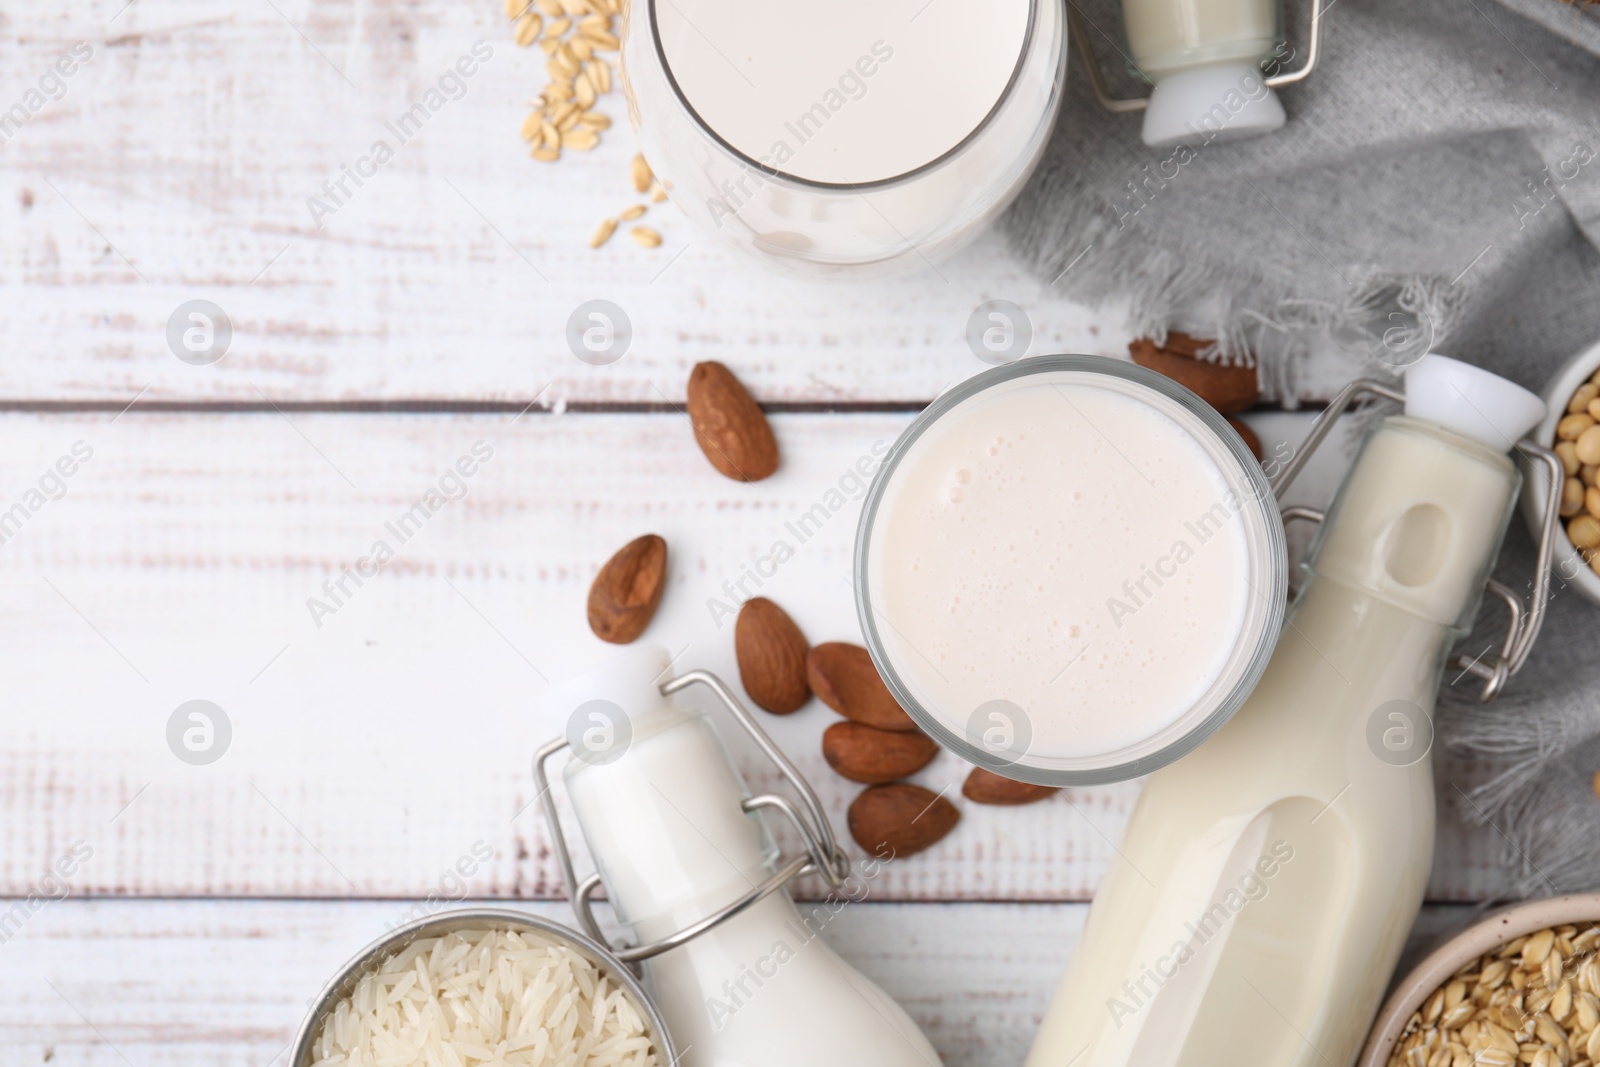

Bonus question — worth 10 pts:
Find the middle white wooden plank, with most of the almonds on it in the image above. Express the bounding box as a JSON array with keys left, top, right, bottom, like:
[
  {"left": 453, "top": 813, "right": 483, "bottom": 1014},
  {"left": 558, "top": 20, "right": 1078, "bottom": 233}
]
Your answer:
[{"left": 0, "top": 411, "right": 1506, "bottom": 901}]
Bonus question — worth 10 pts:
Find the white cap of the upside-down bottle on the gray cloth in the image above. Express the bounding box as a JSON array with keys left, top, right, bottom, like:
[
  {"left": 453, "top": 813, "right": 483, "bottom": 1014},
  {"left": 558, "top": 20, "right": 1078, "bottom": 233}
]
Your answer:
[{"left": 1144, "top": 62, "right": 1283, "bottom": 149}]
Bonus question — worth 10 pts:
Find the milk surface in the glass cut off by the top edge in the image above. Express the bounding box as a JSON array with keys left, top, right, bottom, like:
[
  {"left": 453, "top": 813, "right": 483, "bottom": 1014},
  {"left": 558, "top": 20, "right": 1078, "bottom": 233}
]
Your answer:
[{"left": 654, "top": 0, "right": 1029, "bottom": 184}]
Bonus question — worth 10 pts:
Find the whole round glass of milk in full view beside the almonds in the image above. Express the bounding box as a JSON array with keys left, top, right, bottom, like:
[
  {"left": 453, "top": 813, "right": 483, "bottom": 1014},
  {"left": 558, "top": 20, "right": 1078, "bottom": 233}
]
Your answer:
[{"left": 854, "top": 355, "right": 1288, "bottom": 785}]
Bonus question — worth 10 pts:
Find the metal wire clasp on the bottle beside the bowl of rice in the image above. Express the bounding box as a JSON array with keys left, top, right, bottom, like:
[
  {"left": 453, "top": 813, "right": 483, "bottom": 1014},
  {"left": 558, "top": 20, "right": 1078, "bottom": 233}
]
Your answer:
[{"left": 533, "top": 670, "right": 850, "bottom": 963}]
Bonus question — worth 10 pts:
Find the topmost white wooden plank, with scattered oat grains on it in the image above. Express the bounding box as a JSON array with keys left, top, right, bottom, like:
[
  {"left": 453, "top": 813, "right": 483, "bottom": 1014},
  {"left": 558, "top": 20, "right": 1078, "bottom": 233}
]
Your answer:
[{"left": 0, "top": 0, "right": 1363, "bottom": 405}]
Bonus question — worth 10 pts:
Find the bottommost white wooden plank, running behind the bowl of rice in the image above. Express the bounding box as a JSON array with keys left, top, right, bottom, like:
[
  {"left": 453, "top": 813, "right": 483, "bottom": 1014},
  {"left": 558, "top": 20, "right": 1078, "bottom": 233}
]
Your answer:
[{"left": 0, "top": 901, "right": 1470, "bottom": 1067}]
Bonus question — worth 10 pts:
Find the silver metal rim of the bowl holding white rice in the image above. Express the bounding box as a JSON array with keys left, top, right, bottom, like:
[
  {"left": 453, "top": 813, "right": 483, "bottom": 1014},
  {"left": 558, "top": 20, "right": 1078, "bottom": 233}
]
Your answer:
[{"left": 288, "top": 907, "right": 678, "bottom": 1067}]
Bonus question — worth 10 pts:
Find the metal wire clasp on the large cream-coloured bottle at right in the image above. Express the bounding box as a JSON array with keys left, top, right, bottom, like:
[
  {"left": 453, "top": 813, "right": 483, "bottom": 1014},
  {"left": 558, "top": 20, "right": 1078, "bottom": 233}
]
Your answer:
[{"left": 1270, "top": 378, "right": 1566, "bottom": 704}]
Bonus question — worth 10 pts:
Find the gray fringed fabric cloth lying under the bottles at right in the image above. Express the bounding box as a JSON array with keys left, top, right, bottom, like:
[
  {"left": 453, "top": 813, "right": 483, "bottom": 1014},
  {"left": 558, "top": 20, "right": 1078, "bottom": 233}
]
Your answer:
[{"left": 1003, "top": 0, "right": 1600, "bottom": 896}]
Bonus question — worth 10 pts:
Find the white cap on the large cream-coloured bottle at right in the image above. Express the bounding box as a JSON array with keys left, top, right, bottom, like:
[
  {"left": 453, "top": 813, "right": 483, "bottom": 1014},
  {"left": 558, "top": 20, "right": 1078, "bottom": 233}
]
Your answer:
[{"left": 1405, "top": 355, "right": 1546, "bottom": 453}]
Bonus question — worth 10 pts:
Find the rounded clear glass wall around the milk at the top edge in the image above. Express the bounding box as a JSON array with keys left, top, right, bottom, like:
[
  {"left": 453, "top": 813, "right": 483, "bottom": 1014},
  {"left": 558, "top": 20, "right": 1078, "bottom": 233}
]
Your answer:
[{"left": 622, "top": 0, "right": 1066, "bottom": 278}]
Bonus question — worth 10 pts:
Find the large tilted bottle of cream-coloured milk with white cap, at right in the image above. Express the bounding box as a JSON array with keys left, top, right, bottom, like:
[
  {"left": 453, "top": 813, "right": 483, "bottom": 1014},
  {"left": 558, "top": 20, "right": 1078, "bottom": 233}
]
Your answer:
[{"left": 1027, "top": 357, "right": 1542, "bottom": 1067}]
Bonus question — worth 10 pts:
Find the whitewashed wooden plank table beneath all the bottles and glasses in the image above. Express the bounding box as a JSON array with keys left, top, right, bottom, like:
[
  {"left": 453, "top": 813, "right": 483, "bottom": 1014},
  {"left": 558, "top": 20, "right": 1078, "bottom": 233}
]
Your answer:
[{"left": 0, "top": 0, "right": 1502, "bottom": 1067}]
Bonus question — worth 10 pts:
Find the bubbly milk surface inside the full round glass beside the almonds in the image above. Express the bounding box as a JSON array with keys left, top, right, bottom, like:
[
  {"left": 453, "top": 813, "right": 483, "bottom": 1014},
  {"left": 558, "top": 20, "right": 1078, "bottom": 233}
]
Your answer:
[{"left": 867, "top": 371, "right": 1250, "bottom": 758}]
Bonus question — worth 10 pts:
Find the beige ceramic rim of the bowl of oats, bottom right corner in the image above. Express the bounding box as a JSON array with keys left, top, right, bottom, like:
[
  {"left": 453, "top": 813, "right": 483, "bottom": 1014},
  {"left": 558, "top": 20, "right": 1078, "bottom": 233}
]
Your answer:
[{"left": 1357, "top": 895, "right": 1600, "bottom": 1067}]
